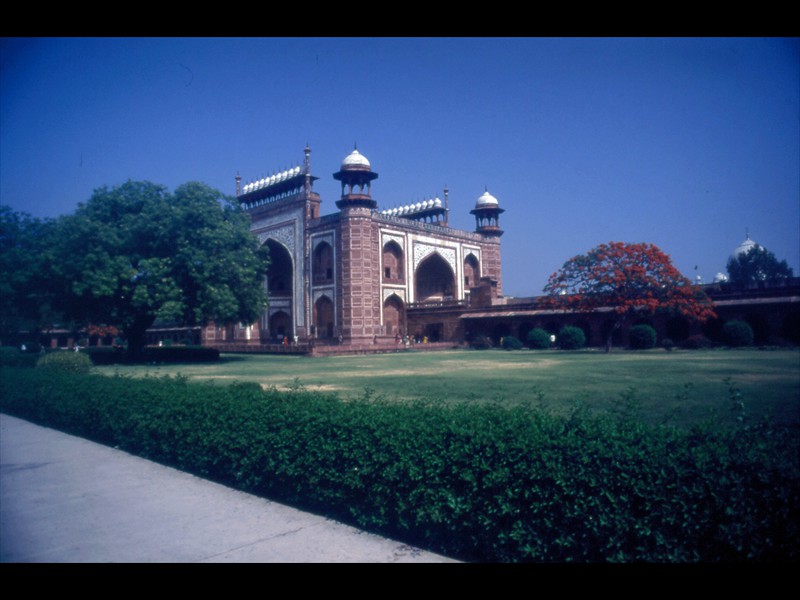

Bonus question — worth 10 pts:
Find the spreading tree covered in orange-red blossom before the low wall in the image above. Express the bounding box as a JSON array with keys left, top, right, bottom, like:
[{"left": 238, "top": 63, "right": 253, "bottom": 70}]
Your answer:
[{"left": 544, "top": 242, "right": 716, "bottom": 352}]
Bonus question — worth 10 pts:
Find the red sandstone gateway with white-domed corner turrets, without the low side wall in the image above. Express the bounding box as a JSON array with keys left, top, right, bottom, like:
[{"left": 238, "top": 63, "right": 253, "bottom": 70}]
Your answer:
[{"left": 209, "top": 147, "right": 503, "bottom": 351}]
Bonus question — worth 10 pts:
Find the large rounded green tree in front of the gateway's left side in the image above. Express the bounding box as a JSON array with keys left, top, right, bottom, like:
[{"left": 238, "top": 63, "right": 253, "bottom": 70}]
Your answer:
[{"left": 51, "top": 181, "right": 269, "bottom": 354}]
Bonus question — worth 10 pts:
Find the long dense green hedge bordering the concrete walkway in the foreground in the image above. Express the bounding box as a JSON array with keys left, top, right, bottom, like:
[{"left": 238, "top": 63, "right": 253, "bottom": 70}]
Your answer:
[{"left": 0, "top": 368, "right": 800, "bottom": 562}]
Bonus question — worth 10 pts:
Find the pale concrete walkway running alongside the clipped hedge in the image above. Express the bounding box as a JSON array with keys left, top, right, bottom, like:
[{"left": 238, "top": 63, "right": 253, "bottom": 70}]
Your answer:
[{"left": 0, "top": 415, "right": 455, "bottom": 563}]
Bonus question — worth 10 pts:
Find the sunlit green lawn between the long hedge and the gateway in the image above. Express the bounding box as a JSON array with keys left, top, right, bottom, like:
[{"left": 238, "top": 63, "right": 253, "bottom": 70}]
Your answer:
[{"left": 97, "top": 349, "right": 800, "bottom": 432}]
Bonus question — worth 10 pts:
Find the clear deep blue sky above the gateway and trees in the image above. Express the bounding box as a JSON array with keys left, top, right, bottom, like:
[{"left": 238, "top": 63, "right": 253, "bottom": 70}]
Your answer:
[{"left": 0, "top": 37, "right": 800, "bottom": 296}]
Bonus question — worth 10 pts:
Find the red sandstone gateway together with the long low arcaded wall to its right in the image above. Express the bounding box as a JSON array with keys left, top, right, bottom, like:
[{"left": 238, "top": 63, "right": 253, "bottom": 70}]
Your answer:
[{"left": 202, "top": 148, "right": 800, "bottom": 354}]
